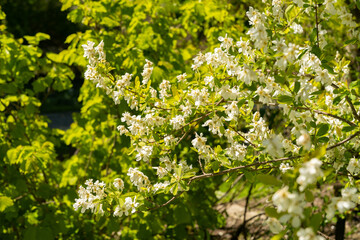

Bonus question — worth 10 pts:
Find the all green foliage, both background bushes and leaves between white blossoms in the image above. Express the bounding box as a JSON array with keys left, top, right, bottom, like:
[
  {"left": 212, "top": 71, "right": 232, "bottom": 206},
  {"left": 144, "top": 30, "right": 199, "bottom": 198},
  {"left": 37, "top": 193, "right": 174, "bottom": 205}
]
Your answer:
[{"left": 0, "top": 0, "right": 360, "bottom": 239}]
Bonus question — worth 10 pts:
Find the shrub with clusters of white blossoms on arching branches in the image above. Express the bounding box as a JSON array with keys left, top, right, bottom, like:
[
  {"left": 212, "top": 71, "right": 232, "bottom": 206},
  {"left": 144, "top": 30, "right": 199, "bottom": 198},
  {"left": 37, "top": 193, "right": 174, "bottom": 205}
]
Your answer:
[{"left": 74, "top": 1, "right": 360, "bottom": 239}]
